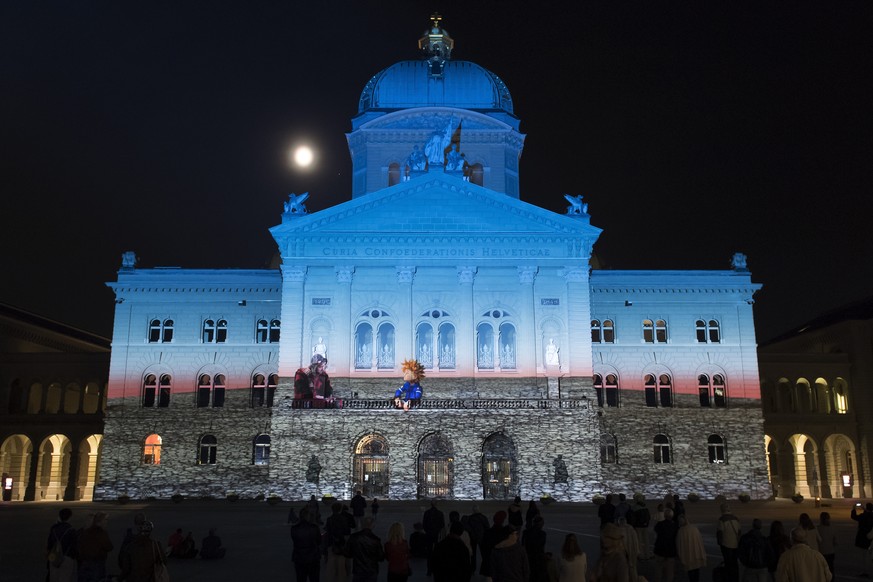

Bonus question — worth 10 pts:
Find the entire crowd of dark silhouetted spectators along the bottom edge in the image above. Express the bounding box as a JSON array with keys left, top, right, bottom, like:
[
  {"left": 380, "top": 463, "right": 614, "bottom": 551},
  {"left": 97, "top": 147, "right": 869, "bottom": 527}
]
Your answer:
[{"left": 46, "top": 492, "right": 873, "bottom": 582}]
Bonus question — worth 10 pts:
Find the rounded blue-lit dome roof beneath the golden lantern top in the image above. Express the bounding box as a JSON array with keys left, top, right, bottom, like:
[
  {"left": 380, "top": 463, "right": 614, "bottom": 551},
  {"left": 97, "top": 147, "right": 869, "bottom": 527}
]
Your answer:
[{"left": 358, "top": 59, "right": 513, "bottom": 114}]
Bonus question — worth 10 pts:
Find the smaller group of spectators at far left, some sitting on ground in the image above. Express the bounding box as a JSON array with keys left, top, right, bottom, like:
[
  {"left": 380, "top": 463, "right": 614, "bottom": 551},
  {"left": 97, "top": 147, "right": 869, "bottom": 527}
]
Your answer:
[{"left": 46, "top": 507, "right": 227, "bottom": 582}]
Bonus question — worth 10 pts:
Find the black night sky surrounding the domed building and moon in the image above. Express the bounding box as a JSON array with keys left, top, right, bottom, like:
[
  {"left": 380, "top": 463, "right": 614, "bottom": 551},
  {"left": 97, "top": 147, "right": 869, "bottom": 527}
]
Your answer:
[{"left": 0, "top": 0, "right": 873, "bottom": 341}]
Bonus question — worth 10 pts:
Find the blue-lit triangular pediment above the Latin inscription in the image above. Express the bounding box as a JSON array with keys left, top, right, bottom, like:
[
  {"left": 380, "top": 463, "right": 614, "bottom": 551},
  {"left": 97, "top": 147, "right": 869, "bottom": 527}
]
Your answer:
[{"left": 270, "top": 172, "right": 601, "bottom": 238}]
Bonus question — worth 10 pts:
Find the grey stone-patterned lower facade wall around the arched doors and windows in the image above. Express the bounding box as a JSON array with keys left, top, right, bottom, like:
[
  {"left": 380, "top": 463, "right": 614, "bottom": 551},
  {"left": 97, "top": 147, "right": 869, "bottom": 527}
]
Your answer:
[{"left": 95, "top": 378, "right": 769, "bottom": 501}]
